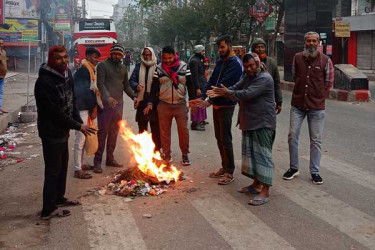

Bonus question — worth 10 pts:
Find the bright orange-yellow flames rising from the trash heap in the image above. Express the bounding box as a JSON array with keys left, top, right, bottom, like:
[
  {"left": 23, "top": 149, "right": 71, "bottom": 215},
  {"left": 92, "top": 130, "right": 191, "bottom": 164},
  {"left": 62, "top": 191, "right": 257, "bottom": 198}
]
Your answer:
[{"left": 119, "top": 121, "right": 181, "bottom": 182}]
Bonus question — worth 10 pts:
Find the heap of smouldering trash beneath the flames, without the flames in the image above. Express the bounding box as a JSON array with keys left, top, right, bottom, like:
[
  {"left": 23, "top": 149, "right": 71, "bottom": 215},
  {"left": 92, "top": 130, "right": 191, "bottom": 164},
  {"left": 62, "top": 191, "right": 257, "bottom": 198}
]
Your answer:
[{"left": 106, "top": 167, "right": 184, "bottom": 198}]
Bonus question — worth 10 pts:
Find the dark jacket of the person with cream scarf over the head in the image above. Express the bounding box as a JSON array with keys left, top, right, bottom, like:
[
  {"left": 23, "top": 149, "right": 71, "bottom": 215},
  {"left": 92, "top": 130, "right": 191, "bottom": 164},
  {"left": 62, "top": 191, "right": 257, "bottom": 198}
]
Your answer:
[{"left": 129, "top": 63, "right": 159, "bottom": 122}]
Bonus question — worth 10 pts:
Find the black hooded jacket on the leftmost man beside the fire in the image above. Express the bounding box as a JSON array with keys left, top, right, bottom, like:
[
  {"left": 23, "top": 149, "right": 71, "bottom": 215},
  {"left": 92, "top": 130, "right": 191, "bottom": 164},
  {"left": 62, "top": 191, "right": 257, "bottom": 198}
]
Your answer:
[{"left": 34, "top": 64, "right": 83, "bottom": 143}]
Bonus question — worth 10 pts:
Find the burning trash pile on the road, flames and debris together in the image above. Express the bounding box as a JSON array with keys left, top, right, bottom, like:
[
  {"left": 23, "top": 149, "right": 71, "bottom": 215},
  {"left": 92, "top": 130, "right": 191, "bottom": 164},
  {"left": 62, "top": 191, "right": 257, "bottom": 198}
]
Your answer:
[{"left": 102, "top": 121, "right": 184, "bottom": 197}]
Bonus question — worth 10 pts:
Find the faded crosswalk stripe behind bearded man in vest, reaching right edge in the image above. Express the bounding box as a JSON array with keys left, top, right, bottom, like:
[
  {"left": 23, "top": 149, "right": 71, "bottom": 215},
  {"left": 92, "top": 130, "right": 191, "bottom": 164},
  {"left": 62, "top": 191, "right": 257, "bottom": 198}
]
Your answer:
[{"left": 302, "top": 155, "right": 375, "bottom": 191}]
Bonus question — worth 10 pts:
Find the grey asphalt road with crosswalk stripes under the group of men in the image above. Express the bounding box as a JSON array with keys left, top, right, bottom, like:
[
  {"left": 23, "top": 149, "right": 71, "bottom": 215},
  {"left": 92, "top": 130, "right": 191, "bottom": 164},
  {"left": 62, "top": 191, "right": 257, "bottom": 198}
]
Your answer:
[{"left": 0, "top": 87, "right": 375, "bottom": 249}]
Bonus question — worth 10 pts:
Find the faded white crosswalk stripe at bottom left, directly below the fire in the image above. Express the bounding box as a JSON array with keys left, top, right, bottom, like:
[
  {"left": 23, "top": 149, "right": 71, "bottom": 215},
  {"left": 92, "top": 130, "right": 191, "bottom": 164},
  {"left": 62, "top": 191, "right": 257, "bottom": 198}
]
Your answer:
[{"left": 82, "top": 197, "right": 147, "bottom": 250}]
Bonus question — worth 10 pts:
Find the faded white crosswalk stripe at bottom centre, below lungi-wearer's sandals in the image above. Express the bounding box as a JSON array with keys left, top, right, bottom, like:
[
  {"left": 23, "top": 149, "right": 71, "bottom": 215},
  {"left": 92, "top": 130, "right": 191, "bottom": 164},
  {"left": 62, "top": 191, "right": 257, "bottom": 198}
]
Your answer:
[{"left": 191, "top": 193, "right": 294, "bottom": 250}]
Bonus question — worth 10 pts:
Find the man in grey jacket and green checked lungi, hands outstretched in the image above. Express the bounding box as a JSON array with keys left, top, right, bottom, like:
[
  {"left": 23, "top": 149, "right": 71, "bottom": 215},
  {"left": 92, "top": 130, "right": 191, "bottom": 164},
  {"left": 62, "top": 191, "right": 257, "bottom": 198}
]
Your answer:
[{"left": 207, "top": 53, "right": 276, "bottom": 206}]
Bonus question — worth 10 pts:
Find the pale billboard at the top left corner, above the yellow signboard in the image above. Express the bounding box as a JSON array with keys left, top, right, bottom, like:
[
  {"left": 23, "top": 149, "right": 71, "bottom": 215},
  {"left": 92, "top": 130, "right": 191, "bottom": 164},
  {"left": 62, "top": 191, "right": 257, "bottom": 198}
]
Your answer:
[{"left": 5, "top": 0, "right": 40, "bottom": 19}]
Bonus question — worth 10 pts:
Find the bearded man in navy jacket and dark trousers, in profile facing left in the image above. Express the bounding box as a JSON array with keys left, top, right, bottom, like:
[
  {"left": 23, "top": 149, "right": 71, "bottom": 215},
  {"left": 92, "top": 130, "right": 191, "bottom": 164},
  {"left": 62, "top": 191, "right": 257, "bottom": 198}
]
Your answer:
[{"left": 198, "top": 35, "right": 243, "bottom": 185}]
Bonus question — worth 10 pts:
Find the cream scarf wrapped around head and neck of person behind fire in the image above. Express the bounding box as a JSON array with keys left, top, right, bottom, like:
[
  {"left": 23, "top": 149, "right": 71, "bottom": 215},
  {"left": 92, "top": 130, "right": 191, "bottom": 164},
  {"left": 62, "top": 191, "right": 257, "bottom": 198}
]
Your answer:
[{"left": 137, "top": 47, "right": 157, "bottom": 102}]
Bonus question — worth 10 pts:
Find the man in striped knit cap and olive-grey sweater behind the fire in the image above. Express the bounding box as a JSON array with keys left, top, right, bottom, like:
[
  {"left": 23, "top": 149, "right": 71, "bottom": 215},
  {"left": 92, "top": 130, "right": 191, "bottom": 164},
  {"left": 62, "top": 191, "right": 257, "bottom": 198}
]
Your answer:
[{"left": 94, "top": 43, "right": 138, "bottom": 173}]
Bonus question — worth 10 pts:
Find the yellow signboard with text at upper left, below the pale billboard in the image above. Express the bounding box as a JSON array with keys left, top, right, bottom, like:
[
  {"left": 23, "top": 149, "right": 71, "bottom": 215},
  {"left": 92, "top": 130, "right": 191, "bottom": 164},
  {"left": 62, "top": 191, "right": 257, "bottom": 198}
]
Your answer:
[{"left": 0, "top": 18, "right": 39, "bottom": 46}]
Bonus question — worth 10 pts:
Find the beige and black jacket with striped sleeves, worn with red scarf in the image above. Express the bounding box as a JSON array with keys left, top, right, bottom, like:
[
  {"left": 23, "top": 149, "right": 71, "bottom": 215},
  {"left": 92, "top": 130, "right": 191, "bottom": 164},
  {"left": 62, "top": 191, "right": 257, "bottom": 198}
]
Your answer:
[{"left": 151, "top": 61, "right": 197, "bottom": 105}]
